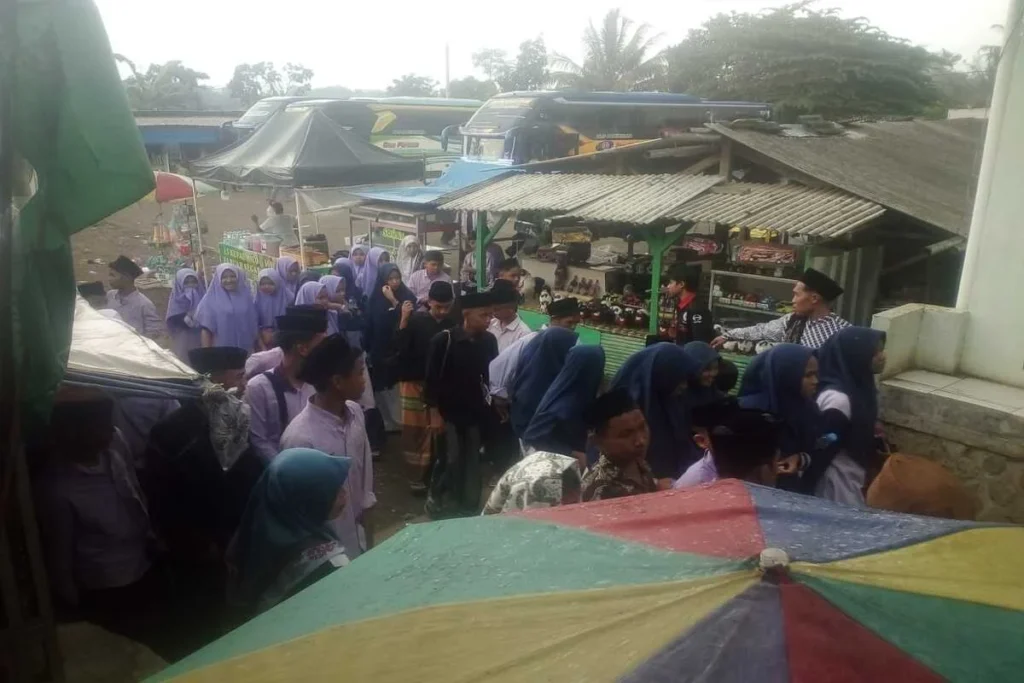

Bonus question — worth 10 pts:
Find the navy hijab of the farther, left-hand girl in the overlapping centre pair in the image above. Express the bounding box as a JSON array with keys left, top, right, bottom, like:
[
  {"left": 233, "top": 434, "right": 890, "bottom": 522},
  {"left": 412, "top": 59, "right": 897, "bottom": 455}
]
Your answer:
[{"left": 509, "top": 328, "right": 579, "bottom": 438}]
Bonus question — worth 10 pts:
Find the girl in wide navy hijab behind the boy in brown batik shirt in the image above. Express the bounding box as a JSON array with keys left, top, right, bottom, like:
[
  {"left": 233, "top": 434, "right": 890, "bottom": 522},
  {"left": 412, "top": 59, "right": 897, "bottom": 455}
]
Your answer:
[{"left": 611, "top": 342, "right": 702, "bottom": 479}]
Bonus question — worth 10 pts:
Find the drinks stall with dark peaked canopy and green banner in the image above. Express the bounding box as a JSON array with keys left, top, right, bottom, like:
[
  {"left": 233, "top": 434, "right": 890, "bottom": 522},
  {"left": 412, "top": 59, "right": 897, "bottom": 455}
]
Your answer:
[{"left": 191, "top": 109, "right": 423, "bottom": 274}]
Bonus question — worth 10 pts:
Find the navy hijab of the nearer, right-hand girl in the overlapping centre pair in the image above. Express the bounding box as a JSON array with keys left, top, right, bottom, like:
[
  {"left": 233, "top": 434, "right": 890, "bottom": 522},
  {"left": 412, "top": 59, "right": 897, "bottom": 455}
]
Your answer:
[{"left": 522, "top": 346, "right": 604, "bottom": 460}]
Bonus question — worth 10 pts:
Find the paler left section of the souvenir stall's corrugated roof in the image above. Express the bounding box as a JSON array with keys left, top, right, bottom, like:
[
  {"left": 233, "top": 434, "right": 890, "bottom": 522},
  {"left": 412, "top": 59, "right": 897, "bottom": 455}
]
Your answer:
[{"left": 440, "top": 173, "right": 722, "bottom": 224}]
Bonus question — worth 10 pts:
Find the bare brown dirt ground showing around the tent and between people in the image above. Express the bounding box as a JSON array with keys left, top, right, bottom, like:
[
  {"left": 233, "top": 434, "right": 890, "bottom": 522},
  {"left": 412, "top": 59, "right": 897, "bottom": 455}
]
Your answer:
[{"left": 72, "top": 191, "right": 425, "bottom": 542}]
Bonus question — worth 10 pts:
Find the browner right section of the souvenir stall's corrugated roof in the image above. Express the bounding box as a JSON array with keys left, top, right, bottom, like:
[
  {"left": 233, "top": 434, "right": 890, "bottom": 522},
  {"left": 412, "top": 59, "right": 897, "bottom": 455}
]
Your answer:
[{"left": 666, "top": 182, "right": 886, "bottom": 238}]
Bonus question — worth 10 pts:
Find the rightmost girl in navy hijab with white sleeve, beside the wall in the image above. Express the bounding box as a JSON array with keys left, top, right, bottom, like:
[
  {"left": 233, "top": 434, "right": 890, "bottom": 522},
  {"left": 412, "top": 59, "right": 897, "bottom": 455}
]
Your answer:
[{"left": 814, "top": 327, "right": 886, "bottom": 506}]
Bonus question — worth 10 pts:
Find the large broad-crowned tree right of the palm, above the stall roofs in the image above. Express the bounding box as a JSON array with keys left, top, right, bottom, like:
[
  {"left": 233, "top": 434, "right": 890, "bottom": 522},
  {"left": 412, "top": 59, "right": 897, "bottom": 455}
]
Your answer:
[{"left": 668, "top": 2, "right": 944, "bottom": 121}]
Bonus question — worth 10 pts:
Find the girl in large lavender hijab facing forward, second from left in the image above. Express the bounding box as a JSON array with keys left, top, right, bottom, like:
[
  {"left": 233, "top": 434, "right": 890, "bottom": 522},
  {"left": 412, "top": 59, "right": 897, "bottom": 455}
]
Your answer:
[{"left": 196, "top": 263, "right": 259, "bottom": 351}]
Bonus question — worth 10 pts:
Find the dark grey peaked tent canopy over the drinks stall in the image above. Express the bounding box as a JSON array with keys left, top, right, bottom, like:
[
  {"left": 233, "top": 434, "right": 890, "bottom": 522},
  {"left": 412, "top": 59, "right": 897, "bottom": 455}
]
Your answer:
[{"left": 191, "top": 109, "right": 423, "bottom": 187}]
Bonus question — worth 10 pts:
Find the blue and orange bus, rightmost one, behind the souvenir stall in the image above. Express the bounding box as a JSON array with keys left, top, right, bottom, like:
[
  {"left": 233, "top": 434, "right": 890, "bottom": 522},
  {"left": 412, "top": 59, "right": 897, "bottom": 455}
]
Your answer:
[{"left": 452, "top": 91, "right": 771, "bottom": 164}]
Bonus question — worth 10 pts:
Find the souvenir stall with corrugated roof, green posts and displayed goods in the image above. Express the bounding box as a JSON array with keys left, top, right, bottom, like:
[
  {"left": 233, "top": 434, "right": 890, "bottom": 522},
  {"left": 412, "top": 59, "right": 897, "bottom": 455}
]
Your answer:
[{"left": 441, "top": 173, "right": 884, "bottom": 373}]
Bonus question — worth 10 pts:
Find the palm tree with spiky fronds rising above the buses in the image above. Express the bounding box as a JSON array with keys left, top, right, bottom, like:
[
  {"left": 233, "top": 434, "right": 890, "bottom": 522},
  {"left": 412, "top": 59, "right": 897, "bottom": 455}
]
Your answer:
[{"left": 551, "top": 9, "right": 665, "bottom": 90}]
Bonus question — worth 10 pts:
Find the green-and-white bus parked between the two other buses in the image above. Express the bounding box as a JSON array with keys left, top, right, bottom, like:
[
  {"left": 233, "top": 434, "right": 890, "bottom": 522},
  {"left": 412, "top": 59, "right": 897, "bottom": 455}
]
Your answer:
[{"left": 287, "top": 97, "right": 482, "bottom": 178}]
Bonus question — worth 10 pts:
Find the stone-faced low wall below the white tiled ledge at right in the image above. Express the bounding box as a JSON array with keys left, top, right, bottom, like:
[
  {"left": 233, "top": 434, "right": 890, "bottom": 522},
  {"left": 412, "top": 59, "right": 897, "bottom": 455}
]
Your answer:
[{"left": 880, "top": 380, "right": 1024, "bottom": 524}]
